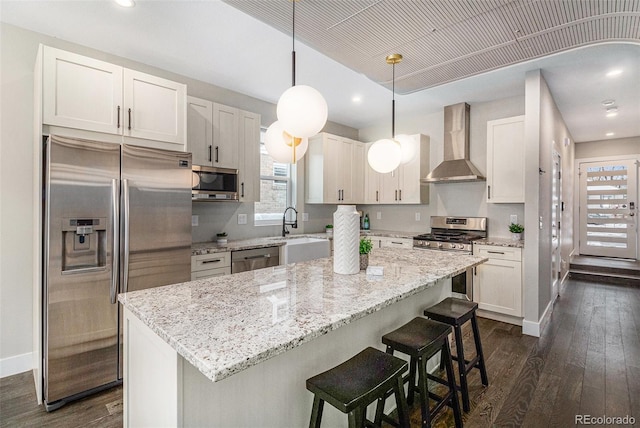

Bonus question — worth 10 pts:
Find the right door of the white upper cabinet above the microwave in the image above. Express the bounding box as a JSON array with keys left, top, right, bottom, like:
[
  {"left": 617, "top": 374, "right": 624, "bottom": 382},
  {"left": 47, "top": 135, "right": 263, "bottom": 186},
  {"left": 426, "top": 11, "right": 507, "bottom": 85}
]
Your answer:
[{"left": 211, "top": 103, "right": 240, "bottom": 169}]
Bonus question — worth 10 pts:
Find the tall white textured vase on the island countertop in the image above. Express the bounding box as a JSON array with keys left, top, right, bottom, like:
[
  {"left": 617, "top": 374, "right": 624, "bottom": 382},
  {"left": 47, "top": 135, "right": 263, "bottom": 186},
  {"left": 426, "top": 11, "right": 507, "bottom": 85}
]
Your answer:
[{"left": 333, "top": 205, "right": 360, "bottom": 275}]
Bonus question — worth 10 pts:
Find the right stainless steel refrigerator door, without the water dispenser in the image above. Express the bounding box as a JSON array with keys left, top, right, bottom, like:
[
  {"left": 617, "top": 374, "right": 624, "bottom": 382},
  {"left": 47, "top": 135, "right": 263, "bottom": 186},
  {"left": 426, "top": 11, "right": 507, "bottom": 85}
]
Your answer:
[{"left": 120, "top": 145, "right": 191, "bottom": 292}]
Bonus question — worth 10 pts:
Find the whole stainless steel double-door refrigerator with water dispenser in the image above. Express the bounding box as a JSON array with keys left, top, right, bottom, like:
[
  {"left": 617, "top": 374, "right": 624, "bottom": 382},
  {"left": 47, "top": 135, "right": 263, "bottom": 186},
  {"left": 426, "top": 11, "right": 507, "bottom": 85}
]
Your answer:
[{"left": 42, "top": 136, "right": 191, "bottom": 410}]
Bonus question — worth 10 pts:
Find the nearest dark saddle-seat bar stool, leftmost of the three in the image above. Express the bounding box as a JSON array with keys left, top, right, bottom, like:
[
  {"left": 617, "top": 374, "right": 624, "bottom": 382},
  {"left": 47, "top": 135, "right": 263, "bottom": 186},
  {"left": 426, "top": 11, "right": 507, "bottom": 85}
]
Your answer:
[{"left": 307, "top": 347, "right": 409, "bottom": 428}]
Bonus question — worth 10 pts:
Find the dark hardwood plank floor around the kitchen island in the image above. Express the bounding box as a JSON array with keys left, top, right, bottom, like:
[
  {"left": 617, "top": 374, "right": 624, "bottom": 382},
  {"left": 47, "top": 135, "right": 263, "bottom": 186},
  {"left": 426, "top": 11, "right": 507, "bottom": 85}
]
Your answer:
[{"left": 0, "top": 279, "right": 640, "bottom": 428}]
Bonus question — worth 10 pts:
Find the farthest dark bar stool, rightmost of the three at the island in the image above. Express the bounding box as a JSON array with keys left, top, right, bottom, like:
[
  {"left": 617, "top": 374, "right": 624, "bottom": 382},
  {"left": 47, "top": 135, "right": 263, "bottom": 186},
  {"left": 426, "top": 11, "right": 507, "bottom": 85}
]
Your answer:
[{"left": 424, "top": 297, "right": 489, "bottom": 412}]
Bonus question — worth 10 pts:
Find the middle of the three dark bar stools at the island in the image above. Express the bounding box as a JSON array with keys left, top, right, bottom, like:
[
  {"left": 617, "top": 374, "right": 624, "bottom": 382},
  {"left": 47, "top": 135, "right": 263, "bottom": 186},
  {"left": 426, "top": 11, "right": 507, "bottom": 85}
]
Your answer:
[{"left": 376, "top": 317, "right": 462, "bottom": 428}]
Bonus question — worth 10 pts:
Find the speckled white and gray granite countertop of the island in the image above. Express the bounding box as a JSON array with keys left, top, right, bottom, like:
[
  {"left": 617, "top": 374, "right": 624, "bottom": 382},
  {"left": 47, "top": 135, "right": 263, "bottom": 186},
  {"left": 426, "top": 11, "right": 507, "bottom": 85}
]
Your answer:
[{"left": 118, "top": 248, "right": 487, "bottom": 382}]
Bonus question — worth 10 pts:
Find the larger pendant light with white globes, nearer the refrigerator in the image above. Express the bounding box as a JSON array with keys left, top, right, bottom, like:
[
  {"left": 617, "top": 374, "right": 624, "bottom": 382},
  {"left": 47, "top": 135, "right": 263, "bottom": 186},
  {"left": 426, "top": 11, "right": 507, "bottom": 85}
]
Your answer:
[{"left": 265, "top": 0, "right": 328, "bottom": 163}]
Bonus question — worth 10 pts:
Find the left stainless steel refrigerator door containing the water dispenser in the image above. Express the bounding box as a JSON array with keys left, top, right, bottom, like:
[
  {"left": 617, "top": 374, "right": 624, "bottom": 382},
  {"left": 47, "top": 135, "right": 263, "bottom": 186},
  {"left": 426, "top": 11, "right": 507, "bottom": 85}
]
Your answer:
[{"left": 43, "top": 136, "right": 120, "bottom": 408}]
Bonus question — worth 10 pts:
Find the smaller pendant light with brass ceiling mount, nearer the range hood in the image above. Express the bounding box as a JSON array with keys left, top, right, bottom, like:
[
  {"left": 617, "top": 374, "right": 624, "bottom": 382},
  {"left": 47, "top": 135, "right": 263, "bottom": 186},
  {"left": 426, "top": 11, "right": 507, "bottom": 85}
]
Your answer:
[{"left": 367, "top": 54, "right": 415, "bottom": 174}]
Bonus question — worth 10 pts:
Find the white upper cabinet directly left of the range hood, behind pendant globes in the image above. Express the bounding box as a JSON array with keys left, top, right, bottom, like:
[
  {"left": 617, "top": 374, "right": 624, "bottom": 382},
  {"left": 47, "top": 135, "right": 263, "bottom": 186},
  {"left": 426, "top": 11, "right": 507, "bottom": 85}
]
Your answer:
[{"left": 365, "top": 134, "right": 430, "bottom": 204}]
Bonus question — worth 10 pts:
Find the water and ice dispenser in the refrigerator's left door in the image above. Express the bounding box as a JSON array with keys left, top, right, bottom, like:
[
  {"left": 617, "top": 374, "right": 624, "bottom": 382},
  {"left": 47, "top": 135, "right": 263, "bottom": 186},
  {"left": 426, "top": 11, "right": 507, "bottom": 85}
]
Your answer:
[{"left": 62, "top": 218, "right": 107, "bottom": 272}]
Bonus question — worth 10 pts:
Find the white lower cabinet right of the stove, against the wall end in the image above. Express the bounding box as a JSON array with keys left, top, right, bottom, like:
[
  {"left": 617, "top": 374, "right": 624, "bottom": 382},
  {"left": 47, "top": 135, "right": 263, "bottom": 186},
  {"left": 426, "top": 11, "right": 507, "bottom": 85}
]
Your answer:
[{"left": 473, "top": 245, "right": 522, "bottom": 317}]
